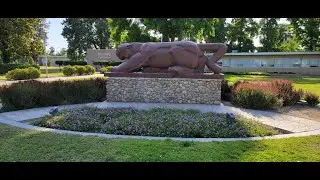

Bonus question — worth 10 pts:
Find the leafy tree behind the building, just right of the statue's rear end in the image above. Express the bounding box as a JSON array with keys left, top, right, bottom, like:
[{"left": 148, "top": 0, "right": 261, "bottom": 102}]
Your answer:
[{"left": 227, "top": 18, "right": 259, "bottom": 52}]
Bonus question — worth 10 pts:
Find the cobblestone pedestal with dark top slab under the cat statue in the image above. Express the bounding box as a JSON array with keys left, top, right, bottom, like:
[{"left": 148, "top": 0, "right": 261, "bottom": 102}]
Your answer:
[{"left": 105, "top": 73, "right": 224, "bottom": 104}]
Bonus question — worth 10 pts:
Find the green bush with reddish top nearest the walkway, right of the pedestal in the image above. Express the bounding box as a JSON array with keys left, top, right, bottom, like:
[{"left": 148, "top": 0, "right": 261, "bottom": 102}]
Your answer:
[{"left": 233, "top": 88, "right": 283, "bottom": 109}]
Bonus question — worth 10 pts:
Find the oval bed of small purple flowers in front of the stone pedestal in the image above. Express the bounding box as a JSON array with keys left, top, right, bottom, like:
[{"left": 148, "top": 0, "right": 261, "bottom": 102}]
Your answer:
[{"left": 31, "top": 107, "right": 280, "bottom": 138}]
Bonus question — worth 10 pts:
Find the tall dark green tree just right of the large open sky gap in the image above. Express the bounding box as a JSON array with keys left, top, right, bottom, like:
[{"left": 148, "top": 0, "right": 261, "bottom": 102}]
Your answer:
[{"left": 62, "top": 18, "right": 110, "bottom": 60}]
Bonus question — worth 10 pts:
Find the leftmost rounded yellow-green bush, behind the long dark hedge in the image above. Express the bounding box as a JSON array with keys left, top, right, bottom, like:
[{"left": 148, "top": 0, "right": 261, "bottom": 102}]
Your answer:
[{"left": 5, "top": 67, "right": 41, "bottom": 80}]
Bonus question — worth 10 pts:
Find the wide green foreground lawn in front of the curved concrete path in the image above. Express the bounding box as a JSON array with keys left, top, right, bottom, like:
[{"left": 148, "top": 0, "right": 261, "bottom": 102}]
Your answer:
[{"left": 0, "top": 124, "right": 320, "bottom": 162}]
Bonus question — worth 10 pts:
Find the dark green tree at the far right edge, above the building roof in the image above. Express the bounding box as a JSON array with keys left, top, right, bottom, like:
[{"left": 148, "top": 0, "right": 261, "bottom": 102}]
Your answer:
[{"left": 287, "top": 18, "right": 320, "bottom": 51}]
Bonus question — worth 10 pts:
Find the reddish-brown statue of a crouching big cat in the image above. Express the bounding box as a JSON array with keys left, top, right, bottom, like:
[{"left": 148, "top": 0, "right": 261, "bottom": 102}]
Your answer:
[{"left": 111, "top": 41, "right": 227, "bottom": 74}]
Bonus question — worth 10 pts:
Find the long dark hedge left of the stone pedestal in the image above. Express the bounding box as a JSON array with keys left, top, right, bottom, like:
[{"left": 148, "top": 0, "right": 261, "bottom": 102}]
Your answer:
[{"left": 0, "top": 78, "right": 106, "bottom": 111}]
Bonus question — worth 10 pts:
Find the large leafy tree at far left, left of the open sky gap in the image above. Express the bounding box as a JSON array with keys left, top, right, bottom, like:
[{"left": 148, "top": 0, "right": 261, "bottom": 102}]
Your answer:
[{"left": 0, "top": 18, "right": 47, "bottom": 63}]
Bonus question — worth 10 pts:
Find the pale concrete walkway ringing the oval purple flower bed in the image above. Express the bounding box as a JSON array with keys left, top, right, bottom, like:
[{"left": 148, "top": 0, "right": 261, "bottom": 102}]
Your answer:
[{"left": 0, "top": 102, "right": 320, "bottom": 142}]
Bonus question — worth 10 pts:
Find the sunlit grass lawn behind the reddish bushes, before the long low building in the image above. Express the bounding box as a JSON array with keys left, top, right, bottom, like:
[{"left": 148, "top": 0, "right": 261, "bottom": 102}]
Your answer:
[{"left": 225, "top": 74, "right": 320, "bottom": 96}]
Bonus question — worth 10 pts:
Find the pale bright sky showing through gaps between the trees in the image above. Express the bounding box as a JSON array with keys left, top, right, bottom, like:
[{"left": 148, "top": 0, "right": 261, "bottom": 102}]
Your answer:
[{"left": 46, "top": 18, "right": 287, "bottom": 52}]
